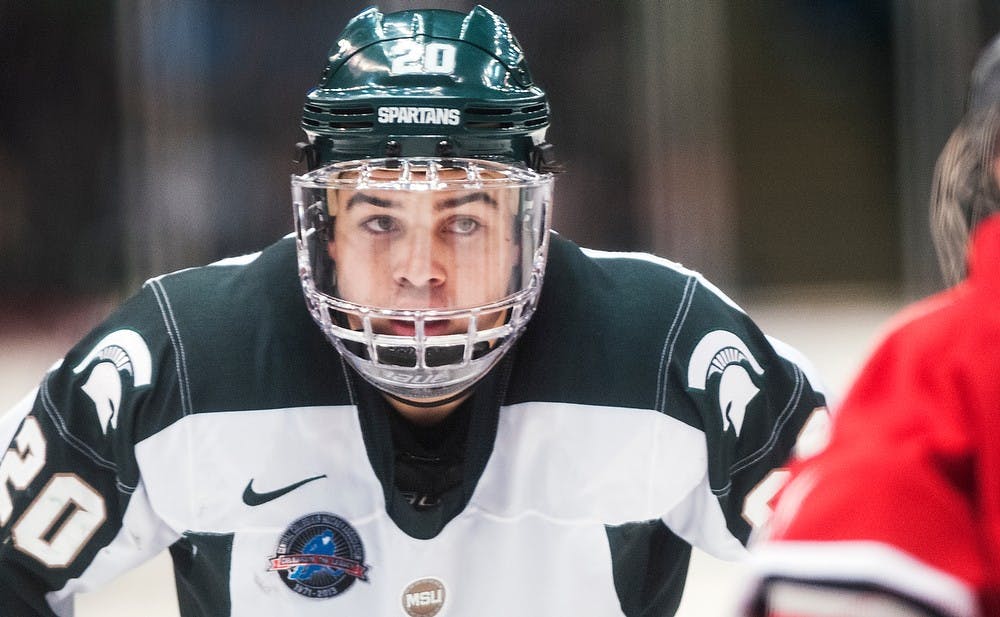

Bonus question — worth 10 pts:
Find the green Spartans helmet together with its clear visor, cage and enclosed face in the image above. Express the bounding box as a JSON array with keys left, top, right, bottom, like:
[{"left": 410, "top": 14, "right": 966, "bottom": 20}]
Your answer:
[{"left": 292, "top": 7, "right": 555, "bottom": 400}]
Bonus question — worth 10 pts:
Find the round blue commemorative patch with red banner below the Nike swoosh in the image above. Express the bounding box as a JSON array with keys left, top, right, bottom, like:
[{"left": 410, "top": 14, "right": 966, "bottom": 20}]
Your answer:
[{"left": 268, "top": 512, "right": 368, "bottom": 599}]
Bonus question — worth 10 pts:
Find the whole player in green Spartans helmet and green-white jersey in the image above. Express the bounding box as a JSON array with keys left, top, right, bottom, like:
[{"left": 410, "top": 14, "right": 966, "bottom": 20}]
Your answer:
[{"left": 0, "top": 8, "right": 824, "bottom": 617}]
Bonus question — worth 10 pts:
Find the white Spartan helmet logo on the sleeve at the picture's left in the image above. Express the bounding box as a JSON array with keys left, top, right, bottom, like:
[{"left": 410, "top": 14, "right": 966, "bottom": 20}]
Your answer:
[{"left": 73, "top": 330, "right": 153, "bottom": 435}]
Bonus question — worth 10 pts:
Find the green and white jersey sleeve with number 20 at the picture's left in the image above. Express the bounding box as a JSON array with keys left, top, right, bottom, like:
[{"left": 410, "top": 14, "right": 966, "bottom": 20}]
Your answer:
[{"left": 0, "top": 288, "right": 183, "bottom": 615}]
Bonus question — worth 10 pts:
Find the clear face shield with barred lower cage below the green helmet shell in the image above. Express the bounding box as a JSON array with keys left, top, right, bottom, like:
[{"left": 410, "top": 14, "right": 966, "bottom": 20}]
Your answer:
[{"left": 292, "top": 158, "right": 553, "bottom": 401}]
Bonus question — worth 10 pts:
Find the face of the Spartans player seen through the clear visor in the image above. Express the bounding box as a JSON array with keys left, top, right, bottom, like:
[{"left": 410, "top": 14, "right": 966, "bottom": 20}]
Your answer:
[{"left": 327, "top": 170, "right": 516, "bottom": 336}]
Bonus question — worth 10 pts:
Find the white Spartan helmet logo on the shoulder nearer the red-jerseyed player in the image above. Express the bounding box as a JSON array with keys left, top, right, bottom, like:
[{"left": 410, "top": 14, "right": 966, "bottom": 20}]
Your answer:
[{"left": 688, "top": 330, "right": 764, "bottom": 437}]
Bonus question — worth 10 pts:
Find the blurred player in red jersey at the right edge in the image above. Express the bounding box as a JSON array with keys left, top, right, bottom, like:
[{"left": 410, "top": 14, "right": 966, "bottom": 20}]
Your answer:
[{"left": 746, "top": 31, "right": 1000, "bottom": 617}]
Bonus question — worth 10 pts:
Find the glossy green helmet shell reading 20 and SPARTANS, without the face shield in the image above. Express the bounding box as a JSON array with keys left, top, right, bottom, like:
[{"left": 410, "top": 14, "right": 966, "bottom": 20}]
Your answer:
[{"left": 298, "top": 6, "right": 555, "bottom": 171}]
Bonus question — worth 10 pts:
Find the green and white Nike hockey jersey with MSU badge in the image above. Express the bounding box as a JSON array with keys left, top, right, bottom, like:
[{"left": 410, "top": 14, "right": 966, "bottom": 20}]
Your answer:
[{"left": 0, "top": 236, "right": 824, "bottom": 617}]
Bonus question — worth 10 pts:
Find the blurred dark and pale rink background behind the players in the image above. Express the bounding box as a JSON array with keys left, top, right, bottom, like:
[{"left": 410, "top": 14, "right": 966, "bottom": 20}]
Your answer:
[{"left": 0, "top": 0, "right": 984, "bottom": 617}]
